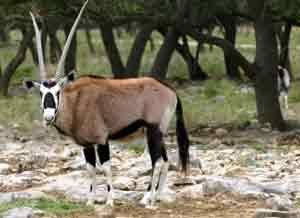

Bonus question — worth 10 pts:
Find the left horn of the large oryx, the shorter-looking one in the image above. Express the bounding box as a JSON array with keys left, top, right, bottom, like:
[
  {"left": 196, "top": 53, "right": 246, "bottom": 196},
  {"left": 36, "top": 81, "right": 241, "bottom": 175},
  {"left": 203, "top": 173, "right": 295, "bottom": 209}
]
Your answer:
[{"left": 30, "top": 12, "right": 46, "bottom": 80}]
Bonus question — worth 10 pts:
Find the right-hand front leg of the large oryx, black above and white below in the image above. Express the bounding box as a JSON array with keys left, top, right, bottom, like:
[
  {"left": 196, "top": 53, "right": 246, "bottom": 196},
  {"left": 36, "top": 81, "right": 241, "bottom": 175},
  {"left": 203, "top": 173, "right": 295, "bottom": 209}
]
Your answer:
[{"left": 95, "top": 143, "right": 114, "bottom": 206}]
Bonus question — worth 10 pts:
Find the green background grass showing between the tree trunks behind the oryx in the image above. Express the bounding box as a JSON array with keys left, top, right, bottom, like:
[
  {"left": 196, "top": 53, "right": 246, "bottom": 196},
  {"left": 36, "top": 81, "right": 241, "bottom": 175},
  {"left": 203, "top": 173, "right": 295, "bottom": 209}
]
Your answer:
[{"left": 0, "top": 28, "right": 300, "bottom": 132}]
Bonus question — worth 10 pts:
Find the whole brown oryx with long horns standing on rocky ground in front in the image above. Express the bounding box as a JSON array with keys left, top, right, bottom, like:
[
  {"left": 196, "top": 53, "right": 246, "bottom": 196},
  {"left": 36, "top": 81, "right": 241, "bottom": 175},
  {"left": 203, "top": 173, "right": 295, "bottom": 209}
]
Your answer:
[{"left": 25, "top": 2, "right": 189, "bottom": 206}]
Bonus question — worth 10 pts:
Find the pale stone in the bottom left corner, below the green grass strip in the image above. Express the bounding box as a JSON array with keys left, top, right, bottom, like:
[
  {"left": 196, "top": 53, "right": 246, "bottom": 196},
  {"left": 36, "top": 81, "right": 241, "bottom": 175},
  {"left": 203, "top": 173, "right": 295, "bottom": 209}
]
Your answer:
[{"left": 2, "top": 207, "right": 44, "bottom": 218}]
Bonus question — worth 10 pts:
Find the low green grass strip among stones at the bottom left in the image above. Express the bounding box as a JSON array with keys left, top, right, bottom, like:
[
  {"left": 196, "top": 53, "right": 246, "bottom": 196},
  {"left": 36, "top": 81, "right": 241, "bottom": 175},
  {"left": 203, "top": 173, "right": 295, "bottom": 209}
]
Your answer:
[{"left": 0, "top": 198, "right": 93, "bottom": 217}]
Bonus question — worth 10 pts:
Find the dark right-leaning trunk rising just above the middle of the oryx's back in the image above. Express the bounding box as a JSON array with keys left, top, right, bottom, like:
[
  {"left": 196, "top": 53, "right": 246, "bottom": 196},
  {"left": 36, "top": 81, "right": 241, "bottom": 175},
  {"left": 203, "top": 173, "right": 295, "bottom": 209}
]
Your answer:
[{"left": 126, "top": 24, "right": 154, "bottom": 77}]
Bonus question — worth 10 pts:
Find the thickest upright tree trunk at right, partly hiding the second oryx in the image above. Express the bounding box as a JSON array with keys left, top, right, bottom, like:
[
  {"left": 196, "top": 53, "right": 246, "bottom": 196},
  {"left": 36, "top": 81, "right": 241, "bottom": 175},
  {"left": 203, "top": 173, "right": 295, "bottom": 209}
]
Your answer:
[{"left": 248, "top": 0, "right": 285, "bottom": 130}]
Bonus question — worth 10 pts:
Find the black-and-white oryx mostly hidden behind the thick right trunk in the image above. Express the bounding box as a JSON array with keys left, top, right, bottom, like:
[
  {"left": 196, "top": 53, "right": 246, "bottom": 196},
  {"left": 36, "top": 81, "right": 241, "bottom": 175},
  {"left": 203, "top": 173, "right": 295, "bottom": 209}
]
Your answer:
[{"left": 277, "top": 65, "right": 291, "bottom": 109}]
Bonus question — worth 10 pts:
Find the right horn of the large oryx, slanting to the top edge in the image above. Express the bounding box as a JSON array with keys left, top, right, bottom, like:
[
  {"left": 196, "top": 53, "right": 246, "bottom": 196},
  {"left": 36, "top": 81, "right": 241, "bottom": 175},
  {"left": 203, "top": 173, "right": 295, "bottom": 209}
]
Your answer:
[{"left": 55, "top": 0, "right": 88, "bottom": 80}]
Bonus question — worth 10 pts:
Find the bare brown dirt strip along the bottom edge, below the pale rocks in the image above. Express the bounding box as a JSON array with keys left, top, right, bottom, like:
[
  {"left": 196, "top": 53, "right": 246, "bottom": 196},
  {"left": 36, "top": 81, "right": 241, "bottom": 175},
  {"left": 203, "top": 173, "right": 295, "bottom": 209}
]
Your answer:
[{"left": 68, "top": 194, "right": 264, "bottom": 218}]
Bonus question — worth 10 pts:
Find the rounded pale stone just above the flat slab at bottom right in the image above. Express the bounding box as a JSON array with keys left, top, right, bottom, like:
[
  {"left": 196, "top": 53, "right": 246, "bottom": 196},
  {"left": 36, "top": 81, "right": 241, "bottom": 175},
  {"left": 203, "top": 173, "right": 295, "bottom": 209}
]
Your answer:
[{"left": 266, "top": 195, "right": 293, "bottom": 211}]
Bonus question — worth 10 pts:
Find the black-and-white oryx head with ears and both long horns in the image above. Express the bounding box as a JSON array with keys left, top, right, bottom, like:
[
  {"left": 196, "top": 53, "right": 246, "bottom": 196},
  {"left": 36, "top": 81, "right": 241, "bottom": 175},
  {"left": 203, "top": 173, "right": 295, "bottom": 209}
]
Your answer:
[{"left": 24, "top": 0, "right": 88, "bottom": 125}]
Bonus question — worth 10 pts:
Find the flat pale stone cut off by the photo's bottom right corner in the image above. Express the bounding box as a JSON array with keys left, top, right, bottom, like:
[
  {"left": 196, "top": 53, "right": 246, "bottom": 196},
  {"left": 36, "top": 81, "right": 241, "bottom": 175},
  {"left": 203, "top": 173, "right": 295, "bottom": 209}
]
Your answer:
[{"left": 254, "top": 209, "right": 300, "bottom": 218}]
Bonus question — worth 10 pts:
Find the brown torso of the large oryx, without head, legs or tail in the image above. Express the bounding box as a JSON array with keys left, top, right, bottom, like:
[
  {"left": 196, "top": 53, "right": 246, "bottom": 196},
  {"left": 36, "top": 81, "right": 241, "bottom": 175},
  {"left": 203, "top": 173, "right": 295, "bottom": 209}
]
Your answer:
[{"left": 55, "top": 76, "right": 177, "bottom": 146}]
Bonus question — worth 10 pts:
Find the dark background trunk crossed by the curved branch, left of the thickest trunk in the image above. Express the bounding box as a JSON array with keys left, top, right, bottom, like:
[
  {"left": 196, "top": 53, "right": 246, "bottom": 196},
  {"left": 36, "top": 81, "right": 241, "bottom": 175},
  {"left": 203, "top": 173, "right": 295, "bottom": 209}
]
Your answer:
[{"left": 220, "top": 16, "right": 241, "bottom": 80}]
